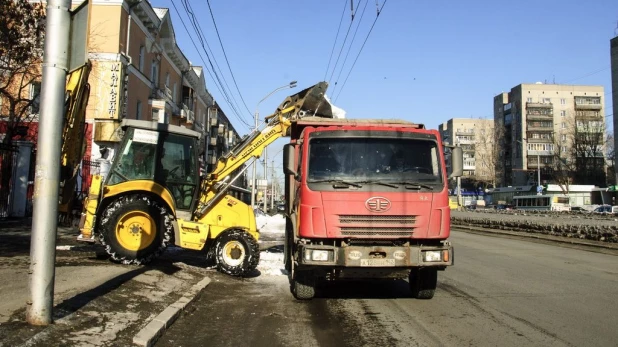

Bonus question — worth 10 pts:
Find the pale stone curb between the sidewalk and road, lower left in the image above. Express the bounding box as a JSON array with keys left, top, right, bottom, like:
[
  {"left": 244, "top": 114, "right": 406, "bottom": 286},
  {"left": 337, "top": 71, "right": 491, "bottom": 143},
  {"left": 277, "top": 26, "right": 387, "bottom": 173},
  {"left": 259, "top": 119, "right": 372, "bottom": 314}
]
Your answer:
[{"left": 133, "top": 277, "right": 210, "bottom": 347}]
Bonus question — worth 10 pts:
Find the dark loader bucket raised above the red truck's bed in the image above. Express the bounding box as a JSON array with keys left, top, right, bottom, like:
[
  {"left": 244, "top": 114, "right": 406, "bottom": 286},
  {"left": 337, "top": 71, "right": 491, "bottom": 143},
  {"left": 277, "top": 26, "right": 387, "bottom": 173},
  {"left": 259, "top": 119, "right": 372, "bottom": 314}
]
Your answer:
[{"left": 277, "top": 82, "right": 333, "bottom": 118}]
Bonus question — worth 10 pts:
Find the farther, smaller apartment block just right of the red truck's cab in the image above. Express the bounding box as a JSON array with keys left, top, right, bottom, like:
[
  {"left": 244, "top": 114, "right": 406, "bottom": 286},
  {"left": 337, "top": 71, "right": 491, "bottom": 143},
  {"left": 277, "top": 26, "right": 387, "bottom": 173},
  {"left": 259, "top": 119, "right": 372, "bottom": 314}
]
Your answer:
[{"left": 438, "top": 118, "right": 495, "bottom": 183}]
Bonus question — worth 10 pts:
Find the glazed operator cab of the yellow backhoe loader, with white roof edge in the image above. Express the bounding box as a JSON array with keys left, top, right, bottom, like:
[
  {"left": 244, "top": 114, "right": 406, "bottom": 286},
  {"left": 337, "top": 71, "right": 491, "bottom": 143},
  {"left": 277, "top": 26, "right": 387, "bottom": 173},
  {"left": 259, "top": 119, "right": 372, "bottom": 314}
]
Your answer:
[{"left": 105, "top": 120, "right": 200, "bottom": 211}]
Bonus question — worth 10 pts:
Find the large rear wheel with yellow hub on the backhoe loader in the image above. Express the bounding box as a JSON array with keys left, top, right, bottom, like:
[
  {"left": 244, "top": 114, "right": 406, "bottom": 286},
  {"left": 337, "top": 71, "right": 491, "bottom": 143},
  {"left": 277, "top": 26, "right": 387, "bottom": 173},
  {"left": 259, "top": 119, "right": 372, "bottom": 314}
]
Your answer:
[{"left": 99, "top": 195, "right": 173, "bottom": 265}]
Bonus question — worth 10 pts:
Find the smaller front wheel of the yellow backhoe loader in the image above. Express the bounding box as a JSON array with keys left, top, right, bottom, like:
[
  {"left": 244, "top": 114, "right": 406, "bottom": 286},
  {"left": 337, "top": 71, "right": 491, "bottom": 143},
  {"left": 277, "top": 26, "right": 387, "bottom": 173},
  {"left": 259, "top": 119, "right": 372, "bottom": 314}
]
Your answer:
[{"left": 215, "top": 230, "right": 260, "bottom": 276}]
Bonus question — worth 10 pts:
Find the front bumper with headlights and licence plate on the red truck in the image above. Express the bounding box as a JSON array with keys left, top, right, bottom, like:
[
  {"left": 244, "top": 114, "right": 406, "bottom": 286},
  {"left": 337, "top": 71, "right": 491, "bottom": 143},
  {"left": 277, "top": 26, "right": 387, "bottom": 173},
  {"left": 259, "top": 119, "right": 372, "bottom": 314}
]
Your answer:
[{"left": 298, "top": 242, "right": 455, "bottom": 269}]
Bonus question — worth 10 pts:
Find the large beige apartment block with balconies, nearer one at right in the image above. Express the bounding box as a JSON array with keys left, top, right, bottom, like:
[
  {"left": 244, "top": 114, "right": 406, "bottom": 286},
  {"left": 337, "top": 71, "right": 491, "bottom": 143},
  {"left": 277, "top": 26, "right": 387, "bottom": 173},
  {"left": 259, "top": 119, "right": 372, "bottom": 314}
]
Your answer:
[{"left": 494, "top": 82, "right": 606, "bottom": 186}]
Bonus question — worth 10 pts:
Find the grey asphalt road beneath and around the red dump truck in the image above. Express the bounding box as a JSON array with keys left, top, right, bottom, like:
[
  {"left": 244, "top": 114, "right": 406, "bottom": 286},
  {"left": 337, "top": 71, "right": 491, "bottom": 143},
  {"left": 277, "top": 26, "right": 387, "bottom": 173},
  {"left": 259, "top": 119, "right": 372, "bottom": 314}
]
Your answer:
[{"left": 157, "top": 232, "right": 618, "bottom": 347}]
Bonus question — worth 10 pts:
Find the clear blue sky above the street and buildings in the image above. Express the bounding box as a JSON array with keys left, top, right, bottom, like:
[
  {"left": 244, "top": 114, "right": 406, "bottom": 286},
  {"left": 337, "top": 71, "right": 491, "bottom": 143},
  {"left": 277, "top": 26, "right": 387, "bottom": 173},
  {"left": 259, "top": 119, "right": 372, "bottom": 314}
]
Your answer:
[{"left": 151, "top": 0, "right": 618, "bottom": 174}]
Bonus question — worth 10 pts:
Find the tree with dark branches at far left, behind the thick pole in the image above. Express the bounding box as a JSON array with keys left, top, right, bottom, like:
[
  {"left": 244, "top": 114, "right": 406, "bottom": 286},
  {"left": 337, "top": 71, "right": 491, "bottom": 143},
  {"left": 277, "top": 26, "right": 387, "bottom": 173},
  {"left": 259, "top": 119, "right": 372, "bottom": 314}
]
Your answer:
[{"left": 0, "top": 0, "right": 45, "bottom": 144}]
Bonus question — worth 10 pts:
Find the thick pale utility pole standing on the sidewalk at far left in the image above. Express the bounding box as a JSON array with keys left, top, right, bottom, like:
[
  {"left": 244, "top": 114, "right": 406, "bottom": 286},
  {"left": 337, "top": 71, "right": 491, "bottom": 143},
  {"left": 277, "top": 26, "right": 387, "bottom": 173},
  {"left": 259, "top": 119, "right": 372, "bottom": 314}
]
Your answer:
[{"left": 26, "top": 0, "right": 71, "bottom": 325}]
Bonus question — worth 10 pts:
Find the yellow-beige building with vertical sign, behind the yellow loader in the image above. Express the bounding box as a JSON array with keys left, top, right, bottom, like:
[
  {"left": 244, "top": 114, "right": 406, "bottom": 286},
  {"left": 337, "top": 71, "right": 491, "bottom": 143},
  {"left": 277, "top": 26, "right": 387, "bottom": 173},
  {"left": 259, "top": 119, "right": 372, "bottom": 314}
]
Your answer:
[{"left": 83, "top": 0, "right": 240, "bottom": 173}]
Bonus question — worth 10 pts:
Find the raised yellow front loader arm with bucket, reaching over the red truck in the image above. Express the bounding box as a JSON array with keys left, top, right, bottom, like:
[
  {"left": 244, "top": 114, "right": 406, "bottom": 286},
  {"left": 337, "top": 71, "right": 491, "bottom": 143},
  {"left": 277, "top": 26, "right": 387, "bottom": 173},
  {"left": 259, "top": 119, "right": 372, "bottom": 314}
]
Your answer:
[{"left": 194, "top": 82, "right": 333, "bottom": 218}]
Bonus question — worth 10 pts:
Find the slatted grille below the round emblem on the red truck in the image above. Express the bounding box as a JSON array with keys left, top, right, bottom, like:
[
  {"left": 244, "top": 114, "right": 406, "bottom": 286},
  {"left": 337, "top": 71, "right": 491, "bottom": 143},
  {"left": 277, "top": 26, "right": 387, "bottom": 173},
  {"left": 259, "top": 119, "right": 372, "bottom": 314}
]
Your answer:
[{"left": 339, "top": 215, "right": 416, "bottom": 237}]
